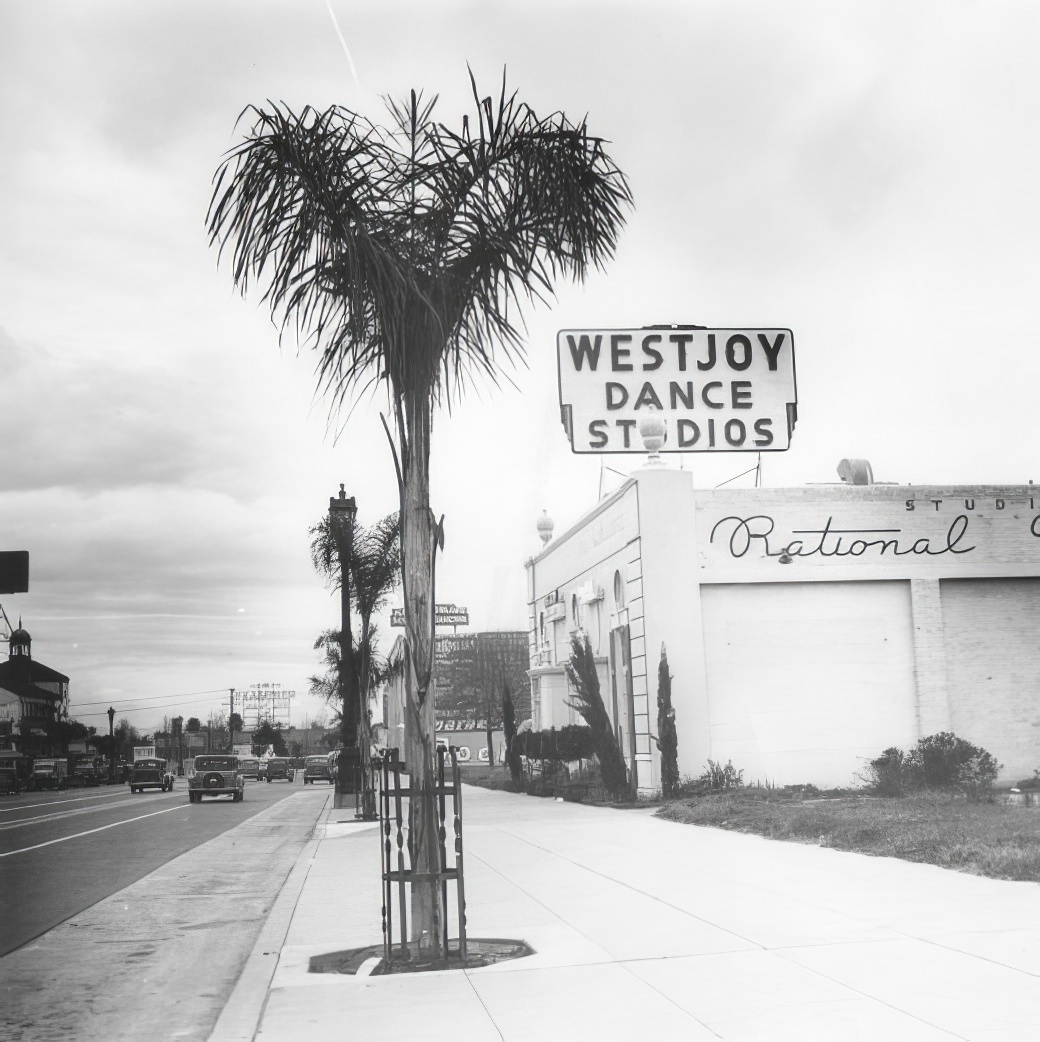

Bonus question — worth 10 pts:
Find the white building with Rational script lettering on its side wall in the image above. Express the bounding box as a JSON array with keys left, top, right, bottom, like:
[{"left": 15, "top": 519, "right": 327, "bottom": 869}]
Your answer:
[{"left": 527, "top": 467, "right": 1040, "bottom": 795}]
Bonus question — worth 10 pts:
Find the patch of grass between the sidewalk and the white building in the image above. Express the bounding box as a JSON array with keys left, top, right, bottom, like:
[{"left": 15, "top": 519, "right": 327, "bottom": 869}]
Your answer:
[{"left": 659, "top": 788, "right": 1040, "bottom": 883}]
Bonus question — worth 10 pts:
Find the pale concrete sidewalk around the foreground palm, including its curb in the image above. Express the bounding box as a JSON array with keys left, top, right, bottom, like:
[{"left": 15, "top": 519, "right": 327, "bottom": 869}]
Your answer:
[{"left": 211, "top": 786, "right": 1040, "bottom": 1042}]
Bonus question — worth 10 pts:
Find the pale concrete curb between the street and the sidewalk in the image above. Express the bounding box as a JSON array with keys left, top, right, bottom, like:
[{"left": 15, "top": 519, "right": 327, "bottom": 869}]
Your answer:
[{"left": 208, "top": 787, "right": 333, "bottom": 1042}]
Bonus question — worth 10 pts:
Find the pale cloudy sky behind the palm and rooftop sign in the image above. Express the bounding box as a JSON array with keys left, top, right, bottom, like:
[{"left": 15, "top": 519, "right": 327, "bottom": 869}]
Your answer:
[{"left": 0, "top": 0, "right": 1040, "bottom": 730}]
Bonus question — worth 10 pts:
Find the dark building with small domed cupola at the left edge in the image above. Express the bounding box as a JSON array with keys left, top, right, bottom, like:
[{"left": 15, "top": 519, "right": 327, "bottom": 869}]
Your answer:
[{"left": 0, "top": 620, "right": 69, "bottom": 756}]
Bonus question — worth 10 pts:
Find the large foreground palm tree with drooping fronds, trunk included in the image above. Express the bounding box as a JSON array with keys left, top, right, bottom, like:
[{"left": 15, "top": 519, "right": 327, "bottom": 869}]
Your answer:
[{"left": 206, "top": 73, "right": 632, "bottom": 954}]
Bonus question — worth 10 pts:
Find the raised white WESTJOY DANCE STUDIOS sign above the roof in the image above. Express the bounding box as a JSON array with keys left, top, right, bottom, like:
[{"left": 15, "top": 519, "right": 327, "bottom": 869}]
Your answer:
[{"left": 556, "top": 326, "right": 797, "bottom": 452}]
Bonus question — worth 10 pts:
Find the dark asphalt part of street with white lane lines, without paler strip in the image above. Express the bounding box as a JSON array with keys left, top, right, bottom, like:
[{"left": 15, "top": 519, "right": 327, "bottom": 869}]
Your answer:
[{"left": 0, "top": 778, "right": 302, "bottom": 957}]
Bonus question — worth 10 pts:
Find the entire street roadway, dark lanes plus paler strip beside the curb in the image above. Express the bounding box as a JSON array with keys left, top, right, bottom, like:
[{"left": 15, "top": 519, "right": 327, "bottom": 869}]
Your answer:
[{"left": 0, "top": 779, "right": 333, "bottom": 1042}]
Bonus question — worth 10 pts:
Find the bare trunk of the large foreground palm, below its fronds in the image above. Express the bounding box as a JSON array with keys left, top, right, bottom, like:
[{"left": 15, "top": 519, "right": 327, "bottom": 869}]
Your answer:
[{"left": 401, "top": 391, "right": 447, "bottom": 958}]
